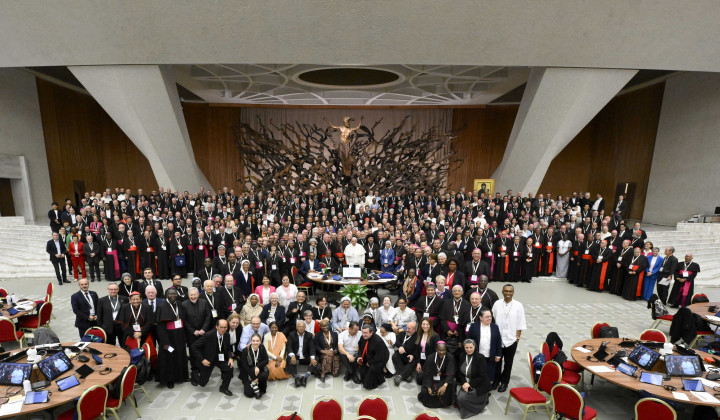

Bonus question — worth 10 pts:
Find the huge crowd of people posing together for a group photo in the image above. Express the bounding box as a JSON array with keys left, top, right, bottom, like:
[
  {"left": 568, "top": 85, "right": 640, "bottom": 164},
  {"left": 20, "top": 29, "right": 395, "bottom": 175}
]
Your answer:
[{"left": 52, "top": 187, "right": 700, "bottom": 417}]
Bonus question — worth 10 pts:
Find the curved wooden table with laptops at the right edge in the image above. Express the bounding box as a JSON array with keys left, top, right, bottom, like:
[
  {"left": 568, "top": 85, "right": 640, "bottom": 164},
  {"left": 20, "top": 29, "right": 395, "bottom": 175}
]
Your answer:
[{"left": 570, "top": 338, "right": 720, "bottom": 407}]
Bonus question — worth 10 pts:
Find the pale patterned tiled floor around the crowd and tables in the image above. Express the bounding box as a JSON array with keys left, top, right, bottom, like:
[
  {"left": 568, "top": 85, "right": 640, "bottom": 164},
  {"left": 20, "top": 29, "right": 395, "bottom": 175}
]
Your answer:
[{"left": 0, "top": 279, "right": 720, "bottom": 420}]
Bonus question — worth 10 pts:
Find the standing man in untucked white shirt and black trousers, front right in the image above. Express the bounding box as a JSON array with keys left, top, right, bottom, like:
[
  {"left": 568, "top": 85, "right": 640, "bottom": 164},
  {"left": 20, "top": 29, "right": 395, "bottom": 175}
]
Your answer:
[{"left": 492, "top": 284, "right": 527, "bottom": 392}]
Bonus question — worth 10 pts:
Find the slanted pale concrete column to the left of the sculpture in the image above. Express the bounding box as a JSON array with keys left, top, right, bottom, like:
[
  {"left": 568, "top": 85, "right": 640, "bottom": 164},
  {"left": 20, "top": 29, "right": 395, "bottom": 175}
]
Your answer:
[{"left": 68, "top": 65, "right": 212, "bottom": 191}]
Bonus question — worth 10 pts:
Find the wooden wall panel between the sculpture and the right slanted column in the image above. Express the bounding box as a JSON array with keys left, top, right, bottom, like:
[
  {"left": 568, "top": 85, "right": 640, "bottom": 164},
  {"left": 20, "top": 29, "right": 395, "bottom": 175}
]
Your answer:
[{"left": 448, "top": 105, "right": 519, "bottom": 191}]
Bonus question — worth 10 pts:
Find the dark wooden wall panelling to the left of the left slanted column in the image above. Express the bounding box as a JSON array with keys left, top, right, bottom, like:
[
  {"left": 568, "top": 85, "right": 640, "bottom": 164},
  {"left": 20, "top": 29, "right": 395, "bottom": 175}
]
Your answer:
[{"left": 37, "top": 79, "right": 157, "bottom": 202}]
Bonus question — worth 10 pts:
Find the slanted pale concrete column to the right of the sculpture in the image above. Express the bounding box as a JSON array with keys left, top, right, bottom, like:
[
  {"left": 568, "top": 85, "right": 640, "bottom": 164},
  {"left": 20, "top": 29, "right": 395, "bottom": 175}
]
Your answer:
[{"left": 493, "top": 67, "right": 637, "bottom": 194}]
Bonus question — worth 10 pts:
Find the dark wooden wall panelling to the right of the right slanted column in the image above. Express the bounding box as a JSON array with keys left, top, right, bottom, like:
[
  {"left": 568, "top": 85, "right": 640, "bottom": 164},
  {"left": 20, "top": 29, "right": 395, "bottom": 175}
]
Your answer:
[{"left": 540, "top": 83, "right": 665, "bottom": 220}]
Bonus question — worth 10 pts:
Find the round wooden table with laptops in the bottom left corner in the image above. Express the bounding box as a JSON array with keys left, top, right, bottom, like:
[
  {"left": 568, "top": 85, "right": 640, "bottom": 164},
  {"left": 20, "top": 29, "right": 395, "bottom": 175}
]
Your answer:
[{"left": 0, "top": 342, "right": 130, "bottom": 418}]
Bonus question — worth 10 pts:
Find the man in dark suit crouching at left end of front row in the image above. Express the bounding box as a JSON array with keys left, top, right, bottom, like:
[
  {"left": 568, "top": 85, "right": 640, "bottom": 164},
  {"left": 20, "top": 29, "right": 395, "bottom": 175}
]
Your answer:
[{"left": 190, "top": 319, "right": 233, "bottom": 397}]
